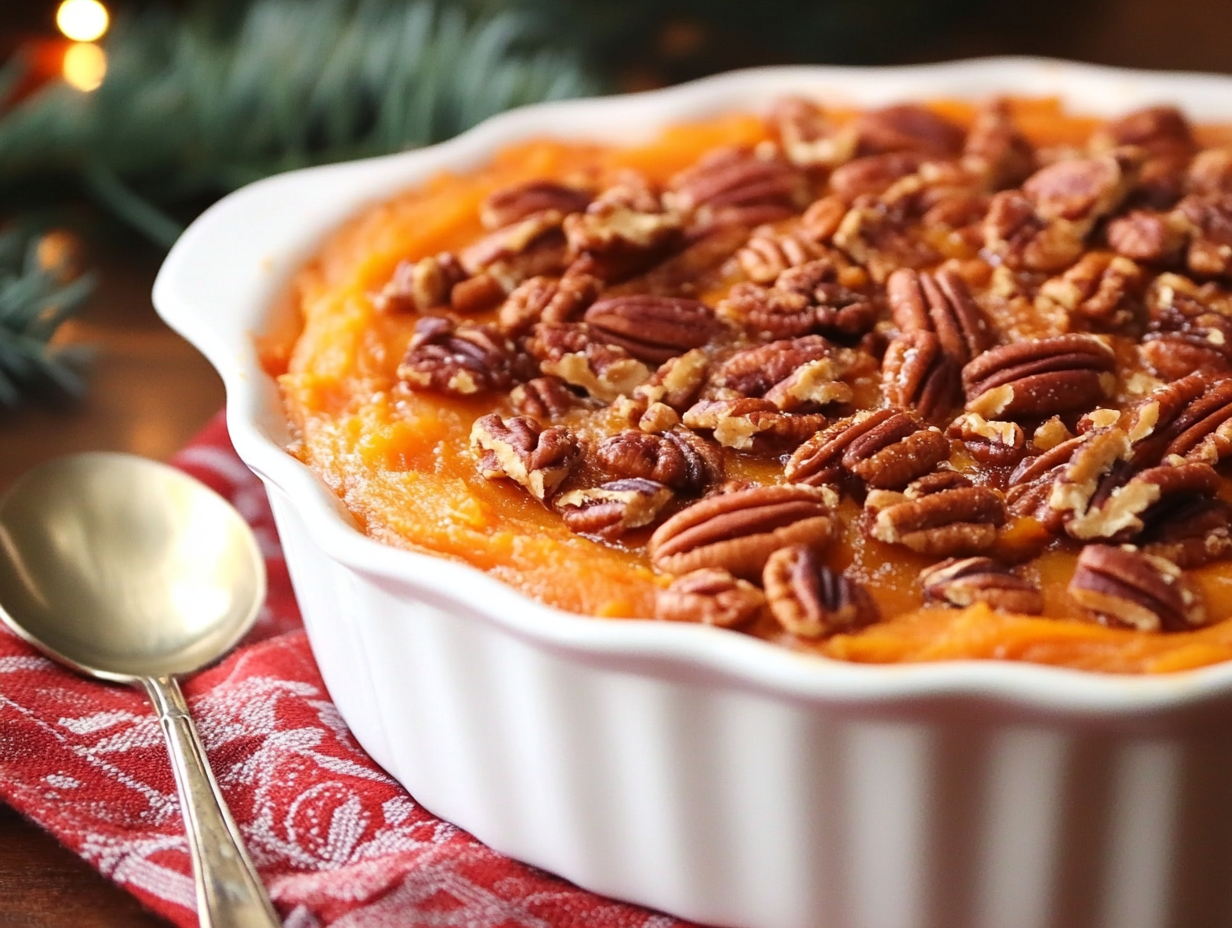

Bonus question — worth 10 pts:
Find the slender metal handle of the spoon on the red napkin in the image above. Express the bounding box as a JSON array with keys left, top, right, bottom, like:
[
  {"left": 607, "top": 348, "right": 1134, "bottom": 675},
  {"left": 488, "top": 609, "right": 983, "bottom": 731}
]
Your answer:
[{"left": 142, "top": 677, "right": 282, "bottom": 928}]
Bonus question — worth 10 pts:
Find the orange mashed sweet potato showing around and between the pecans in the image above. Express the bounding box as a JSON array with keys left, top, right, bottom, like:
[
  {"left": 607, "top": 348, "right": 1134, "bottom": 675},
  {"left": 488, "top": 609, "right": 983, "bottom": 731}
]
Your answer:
[{"left": 277, "top": 100, "right": 1232, "bottom": 673}]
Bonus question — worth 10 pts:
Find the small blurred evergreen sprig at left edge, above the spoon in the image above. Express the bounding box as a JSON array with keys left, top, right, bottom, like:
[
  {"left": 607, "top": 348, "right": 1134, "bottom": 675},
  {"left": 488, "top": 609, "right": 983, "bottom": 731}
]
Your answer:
[{"left": 0, "top": 228, "right": 94, "bottom": 407}]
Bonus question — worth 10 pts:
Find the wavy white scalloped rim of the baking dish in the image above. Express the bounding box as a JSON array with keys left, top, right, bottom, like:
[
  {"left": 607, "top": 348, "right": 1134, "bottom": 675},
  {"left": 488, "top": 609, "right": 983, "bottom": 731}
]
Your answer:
[{"left": 154, "top": 58, "right": 1232, "bottom": 716}]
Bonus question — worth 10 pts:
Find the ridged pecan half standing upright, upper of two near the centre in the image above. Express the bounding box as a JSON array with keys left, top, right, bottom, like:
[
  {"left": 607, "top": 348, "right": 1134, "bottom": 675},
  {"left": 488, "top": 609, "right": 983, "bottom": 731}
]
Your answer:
[{"left": 886, "top": 267, "right": 994, "bottom": 366}]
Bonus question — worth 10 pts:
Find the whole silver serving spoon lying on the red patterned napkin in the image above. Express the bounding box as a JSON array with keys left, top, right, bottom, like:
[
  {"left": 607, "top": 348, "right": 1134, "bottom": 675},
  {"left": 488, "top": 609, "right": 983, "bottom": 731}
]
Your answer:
[{"left": 0, "top": 454, "right": 281, "bottom": 928}]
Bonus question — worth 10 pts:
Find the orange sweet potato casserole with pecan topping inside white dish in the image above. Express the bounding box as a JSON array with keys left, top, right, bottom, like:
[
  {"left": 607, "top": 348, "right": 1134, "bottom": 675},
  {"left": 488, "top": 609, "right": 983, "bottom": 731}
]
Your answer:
[{"left": 272, "top": 99, "right": 1232, "bottom": 672}]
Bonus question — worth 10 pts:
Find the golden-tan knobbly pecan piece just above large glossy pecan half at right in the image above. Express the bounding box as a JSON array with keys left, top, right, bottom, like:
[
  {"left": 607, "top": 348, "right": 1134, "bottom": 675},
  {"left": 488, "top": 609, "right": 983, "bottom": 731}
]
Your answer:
[{"left": 1036, "top": 251, "right": 1146, "bottom": 329}]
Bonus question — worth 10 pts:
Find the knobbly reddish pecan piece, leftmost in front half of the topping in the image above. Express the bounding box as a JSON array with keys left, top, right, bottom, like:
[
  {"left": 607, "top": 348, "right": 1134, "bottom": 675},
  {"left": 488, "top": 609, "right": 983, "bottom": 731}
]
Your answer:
[{"left": 471, "top": 413, "right": 578, "bottom": 500}]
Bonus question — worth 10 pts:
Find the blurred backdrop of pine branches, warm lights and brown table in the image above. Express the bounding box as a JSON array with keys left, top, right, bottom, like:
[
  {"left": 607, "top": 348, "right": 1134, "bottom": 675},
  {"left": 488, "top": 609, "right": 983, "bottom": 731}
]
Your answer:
[{"left": 0, "top": 0, "right": 1232, "bottom": 928}]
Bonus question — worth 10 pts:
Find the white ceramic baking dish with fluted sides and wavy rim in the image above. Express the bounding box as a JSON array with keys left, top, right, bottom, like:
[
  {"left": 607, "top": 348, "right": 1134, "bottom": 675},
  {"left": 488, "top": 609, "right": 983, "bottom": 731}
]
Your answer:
[{"left": 154, "top": 59, "right": 1232, "bottom": 928}]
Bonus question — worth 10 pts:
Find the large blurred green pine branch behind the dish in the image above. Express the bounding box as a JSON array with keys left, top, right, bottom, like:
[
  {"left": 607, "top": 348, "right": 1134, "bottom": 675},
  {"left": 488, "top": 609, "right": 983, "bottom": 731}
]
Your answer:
[{"left": 0, "top": 0, "right": 596, "bottom": 244}]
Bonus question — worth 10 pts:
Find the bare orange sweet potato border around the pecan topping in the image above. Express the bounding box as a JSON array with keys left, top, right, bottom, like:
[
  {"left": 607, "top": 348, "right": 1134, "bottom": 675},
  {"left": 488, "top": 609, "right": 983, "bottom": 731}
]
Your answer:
[{"left": 279, "top": 101, "right": 1232, "bottom": 673}]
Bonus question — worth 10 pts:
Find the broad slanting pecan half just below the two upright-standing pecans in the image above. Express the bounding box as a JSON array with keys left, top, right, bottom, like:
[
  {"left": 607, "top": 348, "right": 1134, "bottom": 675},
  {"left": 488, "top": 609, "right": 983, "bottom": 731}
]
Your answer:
[{"left": 784, "top": 409, "right": 950, "bottom": 488}]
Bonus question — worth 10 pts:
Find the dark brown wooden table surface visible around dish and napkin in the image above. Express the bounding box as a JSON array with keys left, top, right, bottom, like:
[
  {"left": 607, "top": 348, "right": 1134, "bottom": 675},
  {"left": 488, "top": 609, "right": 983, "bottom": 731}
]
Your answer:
[{"left": 0, "top": 0, "right": 1232, "bottom": 928}]
